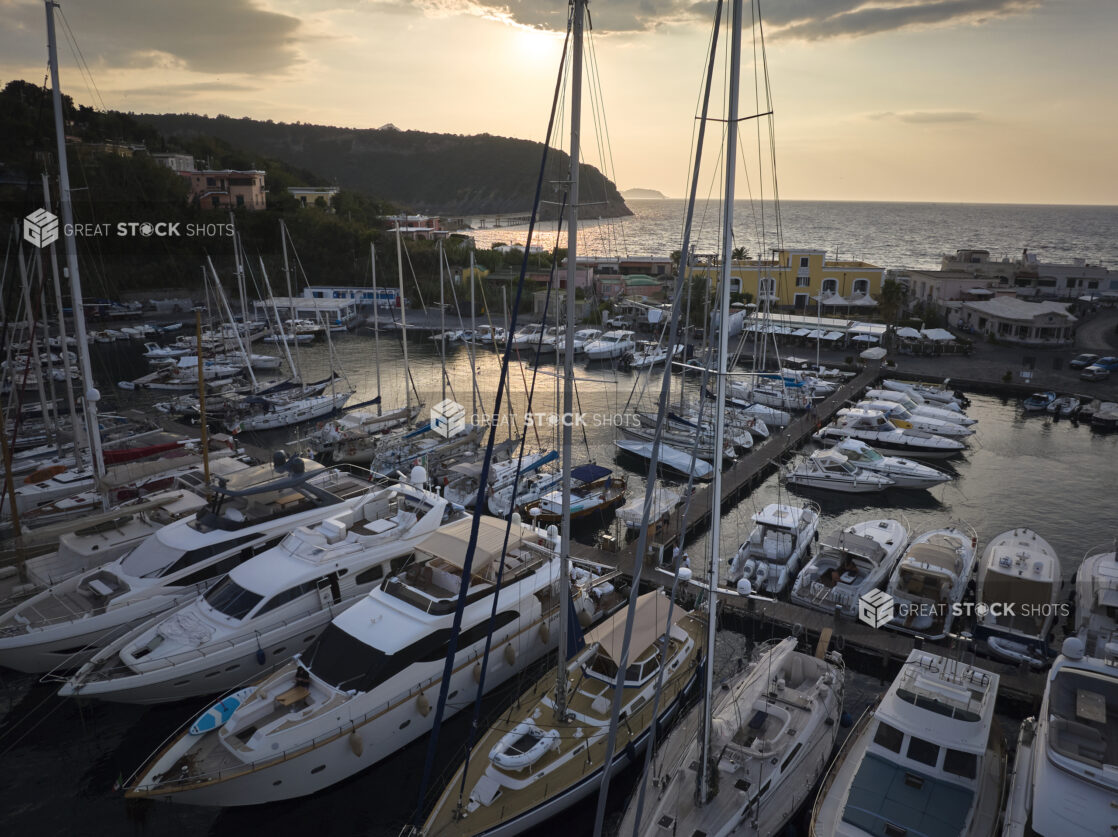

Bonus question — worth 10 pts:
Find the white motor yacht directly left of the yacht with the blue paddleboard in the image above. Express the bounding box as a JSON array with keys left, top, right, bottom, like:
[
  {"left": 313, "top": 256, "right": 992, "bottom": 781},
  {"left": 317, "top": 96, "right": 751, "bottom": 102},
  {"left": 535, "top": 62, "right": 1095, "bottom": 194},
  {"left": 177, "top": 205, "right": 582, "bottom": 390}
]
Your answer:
[{"left": 59, "top": 483, "right": 456, "bottom": 703}]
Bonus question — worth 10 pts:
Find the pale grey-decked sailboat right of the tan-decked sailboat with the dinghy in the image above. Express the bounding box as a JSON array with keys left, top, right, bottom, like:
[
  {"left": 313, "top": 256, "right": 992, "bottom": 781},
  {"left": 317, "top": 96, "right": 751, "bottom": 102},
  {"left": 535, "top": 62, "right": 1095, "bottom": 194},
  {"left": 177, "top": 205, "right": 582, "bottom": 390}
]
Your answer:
[{"left": 618, "top": 637, "right": 845, "bottom": 837}]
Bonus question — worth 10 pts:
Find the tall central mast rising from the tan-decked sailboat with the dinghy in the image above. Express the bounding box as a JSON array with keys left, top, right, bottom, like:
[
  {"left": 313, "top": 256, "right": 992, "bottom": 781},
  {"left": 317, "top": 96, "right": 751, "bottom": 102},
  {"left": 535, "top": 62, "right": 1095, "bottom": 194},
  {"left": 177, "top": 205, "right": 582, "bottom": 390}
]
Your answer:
[{"left": 556, "top": 0, "right": 586, "bottom": 721}]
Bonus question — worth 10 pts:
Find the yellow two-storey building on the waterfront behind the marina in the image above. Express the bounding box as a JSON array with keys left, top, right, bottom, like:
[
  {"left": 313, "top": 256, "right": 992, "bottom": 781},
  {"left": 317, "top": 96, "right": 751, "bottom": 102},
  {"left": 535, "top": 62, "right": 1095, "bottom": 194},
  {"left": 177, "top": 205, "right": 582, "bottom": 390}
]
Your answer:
[{"left": 693, "top": 249, "right": 885, "bottom": 311}]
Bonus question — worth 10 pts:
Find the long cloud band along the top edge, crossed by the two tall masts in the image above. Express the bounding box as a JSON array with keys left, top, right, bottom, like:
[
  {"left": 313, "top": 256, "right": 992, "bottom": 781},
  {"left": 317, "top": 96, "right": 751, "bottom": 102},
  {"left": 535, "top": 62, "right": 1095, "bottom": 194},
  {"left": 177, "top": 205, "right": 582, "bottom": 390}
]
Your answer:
[{"left": 418, "top": 0, "right": 1043, "bottom": 40}]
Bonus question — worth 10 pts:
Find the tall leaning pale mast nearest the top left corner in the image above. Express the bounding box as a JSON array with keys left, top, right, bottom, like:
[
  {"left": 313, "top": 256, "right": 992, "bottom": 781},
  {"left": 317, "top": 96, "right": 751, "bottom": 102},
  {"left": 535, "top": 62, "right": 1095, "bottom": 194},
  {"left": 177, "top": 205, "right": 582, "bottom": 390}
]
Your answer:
[{"left": 45, "top": 0, "right": 105, "bottom": 478}]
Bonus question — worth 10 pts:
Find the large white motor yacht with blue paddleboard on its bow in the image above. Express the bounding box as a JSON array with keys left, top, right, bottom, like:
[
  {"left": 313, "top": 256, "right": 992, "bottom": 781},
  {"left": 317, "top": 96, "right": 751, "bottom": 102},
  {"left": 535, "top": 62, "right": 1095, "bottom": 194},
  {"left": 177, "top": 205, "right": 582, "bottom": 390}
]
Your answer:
[{"left": 127, "top": 516, "right": 621, "bottom": 806}]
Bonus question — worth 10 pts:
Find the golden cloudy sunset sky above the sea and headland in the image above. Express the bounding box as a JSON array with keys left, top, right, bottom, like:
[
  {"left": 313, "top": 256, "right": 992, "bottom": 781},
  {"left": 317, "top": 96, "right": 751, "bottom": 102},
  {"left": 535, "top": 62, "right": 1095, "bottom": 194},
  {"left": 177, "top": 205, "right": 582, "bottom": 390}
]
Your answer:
[{"left": 0, "top": 0, "right": 1118, "bottom": 205}]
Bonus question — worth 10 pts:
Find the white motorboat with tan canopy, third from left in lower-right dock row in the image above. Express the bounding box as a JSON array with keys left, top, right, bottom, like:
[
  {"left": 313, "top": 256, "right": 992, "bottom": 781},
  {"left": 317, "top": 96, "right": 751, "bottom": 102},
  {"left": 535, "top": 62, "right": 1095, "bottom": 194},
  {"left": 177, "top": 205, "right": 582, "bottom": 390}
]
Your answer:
[{"left": 883, "top": 525, "right": 978, "bottom": 639}]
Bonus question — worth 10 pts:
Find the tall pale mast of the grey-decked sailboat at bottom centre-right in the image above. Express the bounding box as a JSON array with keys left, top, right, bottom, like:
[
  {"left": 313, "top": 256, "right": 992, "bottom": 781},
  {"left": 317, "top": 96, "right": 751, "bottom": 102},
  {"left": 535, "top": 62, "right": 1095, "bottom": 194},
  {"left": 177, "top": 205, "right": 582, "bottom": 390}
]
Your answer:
[{"left": 698, "top": 0, "right": 741, "bottom": 805}]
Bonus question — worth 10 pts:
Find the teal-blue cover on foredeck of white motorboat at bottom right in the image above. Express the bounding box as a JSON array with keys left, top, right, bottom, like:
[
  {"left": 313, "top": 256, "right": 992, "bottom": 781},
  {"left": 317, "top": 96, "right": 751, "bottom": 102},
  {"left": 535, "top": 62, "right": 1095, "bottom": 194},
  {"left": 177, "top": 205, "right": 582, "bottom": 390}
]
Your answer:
[{"left": 842, "top": 753, "right": 974, "bottom": 837}]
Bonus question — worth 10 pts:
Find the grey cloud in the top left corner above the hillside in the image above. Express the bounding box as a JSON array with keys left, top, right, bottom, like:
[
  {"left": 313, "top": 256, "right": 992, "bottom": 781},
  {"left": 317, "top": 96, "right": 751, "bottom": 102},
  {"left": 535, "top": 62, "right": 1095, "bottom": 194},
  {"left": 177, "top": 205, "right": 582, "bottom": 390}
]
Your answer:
[{"left": 0, "top": 0, "right": 301, "bottom": 75}]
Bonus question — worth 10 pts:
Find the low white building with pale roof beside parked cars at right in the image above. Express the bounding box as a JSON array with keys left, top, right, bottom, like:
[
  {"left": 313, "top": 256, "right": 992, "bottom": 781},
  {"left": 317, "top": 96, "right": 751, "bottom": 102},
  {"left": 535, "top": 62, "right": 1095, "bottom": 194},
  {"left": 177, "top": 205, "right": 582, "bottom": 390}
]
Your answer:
[{"left": 949, "top": 296, "right": 1078, "bottom": 345}]
